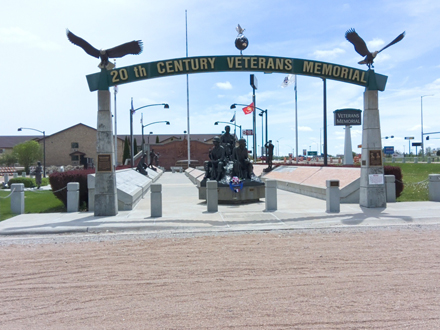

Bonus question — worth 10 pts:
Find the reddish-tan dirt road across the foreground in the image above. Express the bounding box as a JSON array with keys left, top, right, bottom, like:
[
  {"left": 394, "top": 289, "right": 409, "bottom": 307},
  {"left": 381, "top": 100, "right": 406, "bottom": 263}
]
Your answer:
[{"left": 0, "top": 227, "right": 440, "bottom": 329}]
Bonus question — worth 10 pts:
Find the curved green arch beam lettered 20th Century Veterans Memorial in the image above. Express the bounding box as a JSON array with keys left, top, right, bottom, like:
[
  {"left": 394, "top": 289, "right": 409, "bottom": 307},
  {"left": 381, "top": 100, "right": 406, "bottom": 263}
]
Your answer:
[{"left": 87, "top": 56, "right": 387, "bottom": 92}]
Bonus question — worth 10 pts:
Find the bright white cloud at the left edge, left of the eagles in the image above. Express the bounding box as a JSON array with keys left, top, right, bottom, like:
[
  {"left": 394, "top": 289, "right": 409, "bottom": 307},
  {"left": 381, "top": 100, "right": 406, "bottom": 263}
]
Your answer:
[{"left": 0, "top": 27, "right": 60, "bottom": 50}]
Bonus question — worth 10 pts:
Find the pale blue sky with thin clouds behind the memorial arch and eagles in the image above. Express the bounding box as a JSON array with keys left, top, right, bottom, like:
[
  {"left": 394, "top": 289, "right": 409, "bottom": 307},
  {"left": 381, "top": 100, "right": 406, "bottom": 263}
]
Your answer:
[{"left": 0, "top": 0, "right": 440, "bottom": 155}]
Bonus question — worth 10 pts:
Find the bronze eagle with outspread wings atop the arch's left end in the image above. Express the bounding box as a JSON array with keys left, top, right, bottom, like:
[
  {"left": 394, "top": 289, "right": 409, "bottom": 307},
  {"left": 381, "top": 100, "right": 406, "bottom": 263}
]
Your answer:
[{"left": 66, "top": 30, "right": 143, "bottom": 70}]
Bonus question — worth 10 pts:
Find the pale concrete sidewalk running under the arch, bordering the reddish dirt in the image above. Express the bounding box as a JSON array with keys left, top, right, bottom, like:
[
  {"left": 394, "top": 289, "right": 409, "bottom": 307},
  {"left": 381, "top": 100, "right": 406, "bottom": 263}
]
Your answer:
[{"left": 0, "top": 172, "right": 440, "bottom": 235}]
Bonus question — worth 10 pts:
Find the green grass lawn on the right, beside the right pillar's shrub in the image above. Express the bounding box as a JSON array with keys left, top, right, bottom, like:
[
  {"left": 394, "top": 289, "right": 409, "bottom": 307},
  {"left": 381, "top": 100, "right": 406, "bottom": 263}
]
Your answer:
[{"left": 385, "top": 163, "right": 440, "bottom": 202}]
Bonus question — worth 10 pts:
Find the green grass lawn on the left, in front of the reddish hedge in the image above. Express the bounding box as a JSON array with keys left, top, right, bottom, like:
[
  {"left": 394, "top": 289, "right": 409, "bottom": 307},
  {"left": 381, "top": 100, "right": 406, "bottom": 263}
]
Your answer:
[{"left": 0, "top": 190, "right": 66, "bottom": 221}]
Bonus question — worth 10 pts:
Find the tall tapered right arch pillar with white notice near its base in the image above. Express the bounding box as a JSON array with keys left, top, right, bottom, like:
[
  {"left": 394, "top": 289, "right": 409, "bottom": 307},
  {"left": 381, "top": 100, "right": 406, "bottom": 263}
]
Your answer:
[{"left": 359, "top": 86, "right": 386, "bottom": 208}]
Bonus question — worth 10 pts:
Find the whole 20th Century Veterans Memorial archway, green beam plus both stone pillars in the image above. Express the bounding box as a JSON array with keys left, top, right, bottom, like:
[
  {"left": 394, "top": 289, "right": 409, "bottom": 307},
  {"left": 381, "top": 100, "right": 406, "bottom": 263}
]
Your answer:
[{"left": 87, "top": 56, "right": 387, "bottom": 215}]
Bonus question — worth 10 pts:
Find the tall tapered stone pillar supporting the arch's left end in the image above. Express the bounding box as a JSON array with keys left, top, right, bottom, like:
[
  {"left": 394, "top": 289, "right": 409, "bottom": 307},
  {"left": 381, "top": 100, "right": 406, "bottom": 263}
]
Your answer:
[{"left": 94, "top": 89, "right": 118, "bottom": 216}]
